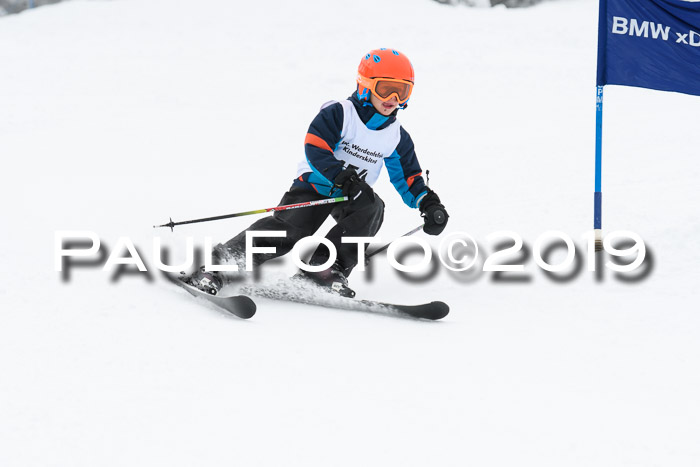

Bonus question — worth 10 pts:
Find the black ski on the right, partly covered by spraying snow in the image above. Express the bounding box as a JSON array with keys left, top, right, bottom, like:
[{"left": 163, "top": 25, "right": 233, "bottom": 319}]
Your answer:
[{"left": 240, "top": 281, "right": 450, "bottom": 320}]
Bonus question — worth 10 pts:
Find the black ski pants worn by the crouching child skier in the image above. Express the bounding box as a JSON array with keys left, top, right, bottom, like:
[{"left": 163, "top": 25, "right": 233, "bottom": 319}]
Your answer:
[{"left": 214, "top": 186, "right": 384, "bottom": 276}]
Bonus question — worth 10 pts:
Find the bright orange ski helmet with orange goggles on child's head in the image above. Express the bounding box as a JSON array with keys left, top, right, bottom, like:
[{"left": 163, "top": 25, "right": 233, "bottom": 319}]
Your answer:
[{"left": 357, "top": 49, "right": 415, "bottom": 108}]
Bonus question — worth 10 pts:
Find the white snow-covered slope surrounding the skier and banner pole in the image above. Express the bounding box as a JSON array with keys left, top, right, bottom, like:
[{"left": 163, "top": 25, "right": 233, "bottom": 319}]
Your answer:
[{"left": 0, "top": 0, "right": 700, "bottom": 467}]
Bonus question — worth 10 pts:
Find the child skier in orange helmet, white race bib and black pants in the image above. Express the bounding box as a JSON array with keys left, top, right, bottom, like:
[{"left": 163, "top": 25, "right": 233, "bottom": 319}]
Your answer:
[{"left": 186, "top": 49, "right": 448, "bottom": 297}]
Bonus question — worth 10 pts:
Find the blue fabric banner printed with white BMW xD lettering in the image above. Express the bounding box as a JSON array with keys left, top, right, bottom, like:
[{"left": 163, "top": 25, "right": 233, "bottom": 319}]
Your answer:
[{"left": 597, "top": 0, "right": 700, "bottom": 95}]
